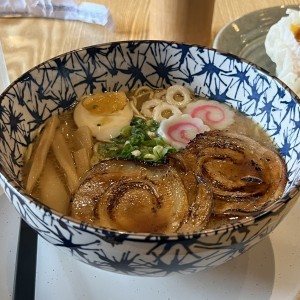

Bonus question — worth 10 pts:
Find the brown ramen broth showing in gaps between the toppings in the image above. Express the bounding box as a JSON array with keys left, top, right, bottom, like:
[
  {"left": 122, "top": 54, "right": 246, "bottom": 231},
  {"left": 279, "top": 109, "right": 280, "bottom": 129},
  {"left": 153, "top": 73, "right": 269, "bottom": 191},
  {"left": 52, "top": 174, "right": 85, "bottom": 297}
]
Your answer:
[{"left": 23, "top": 88, "right": 284, "bottom": 228}]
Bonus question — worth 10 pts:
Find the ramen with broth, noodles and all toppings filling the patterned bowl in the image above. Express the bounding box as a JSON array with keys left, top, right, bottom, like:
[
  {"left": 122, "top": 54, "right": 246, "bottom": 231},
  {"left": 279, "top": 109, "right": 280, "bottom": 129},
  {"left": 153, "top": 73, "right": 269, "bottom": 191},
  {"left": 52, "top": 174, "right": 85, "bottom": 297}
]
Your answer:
[{"left": 24, "top": 85, "right": 287, "bottom": 233}]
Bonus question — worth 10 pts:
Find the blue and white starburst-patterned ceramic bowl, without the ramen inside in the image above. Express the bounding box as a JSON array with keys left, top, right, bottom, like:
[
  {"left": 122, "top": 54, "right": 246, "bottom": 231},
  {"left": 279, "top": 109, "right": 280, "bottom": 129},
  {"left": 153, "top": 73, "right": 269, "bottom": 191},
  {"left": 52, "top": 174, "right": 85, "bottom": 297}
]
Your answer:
[{"left": 0, "top": 41, "right": 300, "bottom": 276}]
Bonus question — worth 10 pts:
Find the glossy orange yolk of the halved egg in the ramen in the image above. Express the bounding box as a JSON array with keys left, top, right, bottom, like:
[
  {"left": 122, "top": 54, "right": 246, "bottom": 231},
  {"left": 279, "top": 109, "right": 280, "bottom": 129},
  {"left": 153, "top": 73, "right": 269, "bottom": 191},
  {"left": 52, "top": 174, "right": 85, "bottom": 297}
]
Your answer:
[{"left": 82, "top": 92, "right": 127, "bottom": 115}]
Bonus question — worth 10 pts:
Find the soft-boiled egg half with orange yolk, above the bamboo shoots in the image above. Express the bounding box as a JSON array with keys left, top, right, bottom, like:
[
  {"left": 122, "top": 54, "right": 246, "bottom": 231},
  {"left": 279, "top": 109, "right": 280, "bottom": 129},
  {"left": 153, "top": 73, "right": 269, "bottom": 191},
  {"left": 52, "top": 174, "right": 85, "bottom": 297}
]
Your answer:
[{"left": 74, "top": 92, "right": 133, "bottom": 141}]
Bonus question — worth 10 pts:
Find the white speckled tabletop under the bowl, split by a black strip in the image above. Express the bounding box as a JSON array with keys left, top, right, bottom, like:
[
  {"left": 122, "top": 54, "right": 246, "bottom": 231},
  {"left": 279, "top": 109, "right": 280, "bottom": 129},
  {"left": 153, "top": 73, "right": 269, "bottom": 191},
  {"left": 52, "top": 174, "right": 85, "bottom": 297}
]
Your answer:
[{"left": 0, "top": 189, "right": 300, "bottom": 300}]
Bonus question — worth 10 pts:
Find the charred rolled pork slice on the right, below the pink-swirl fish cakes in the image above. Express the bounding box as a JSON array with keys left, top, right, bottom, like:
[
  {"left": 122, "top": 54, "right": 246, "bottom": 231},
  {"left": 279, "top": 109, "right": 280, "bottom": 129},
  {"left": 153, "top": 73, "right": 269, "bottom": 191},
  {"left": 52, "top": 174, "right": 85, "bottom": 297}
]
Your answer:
[{"left": 170, "top": 130, "right": 287, "bottom": 215}]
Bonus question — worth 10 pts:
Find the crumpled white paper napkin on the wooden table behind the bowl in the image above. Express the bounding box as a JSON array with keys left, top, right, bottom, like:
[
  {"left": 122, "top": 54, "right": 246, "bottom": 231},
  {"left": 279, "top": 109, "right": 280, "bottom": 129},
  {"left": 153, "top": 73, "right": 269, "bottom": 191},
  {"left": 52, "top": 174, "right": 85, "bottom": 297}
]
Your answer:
[{"left": 0, "top": 0, "right": 112, "bottom": 28}]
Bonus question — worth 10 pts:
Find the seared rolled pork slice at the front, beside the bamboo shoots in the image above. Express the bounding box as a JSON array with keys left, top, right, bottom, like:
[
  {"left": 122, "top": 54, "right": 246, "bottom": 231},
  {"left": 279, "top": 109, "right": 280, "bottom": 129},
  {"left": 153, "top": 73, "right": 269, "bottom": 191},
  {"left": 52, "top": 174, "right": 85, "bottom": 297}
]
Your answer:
[{"left": 70, "top": 159, "right": 212, "bottom": 233}]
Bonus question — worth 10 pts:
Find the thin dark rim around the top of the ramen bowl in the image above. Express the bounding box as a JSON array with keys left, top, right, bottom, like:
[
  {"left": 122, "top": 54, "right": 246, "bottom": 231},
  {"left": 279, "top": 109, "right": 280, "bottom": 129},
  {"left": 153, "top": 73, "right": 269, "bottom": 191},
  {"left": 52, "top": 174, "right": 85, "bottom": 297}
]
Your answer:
[{"left": 0, "top": 39, "right": 300, "bottom": 242}]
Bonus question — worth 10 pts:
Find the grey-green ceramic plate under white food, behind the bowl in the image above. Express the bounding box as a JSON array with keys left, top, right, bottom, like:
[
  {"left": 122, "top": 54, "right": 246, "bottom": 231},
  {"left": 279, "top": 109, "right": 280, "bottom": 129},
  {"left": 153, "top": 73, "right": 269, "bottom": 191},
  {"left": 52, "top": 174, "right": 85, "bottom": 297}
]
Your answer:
[{"left": 213, "top": 5, "right": 300, "bottom": 75}]
